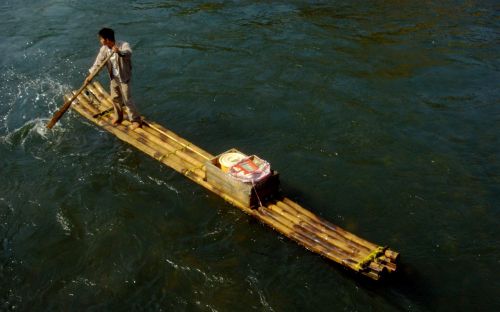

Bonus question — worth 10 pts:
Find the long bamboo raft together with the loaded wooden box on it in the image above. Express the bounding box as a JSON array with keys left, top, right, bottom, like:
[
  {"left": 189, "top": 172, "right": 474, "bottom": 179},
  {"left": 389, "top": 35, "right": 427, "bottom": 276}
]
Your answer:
[{"left": 58, "top": 82, "right": 399, "bottom": 280}]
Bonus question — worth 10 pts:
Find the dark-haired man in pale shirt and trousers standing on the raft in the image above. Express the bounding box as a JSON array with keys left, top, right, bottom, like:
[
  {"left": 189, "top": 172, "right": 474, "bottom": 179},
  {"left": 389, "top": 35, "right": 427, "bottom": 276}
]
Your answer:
[{"left": 85, "top": 28, "right": 142, "bottom": 130}]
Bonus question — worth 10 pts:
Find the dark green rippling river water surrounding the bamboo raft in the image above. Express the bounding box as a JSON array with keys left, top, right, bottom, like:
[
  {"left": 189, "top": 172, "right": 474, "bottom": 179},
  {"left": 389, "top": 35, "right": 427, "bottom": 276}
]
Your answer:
[{"left": 0, "top": 0, "right": 500, "bottom": 311}]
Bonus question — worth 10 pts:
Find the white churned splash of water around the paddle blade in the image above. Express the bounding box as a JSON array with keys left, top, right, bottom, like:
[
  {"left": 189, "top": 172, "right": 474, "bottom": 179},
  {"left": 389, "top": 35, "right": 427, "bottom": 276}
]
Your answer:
[{"left": 0, "top": 59, "right": 83, "bottom": 165}]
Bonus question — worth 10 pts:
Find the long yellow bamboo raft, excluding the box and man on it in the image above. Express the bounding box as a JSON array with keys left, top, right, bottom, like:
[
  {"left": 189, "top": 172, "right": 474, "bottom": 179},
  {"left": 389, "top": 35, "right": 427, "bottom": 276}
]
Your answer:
[{"left": 65, "top": 82, "right": 399, "bottom": 280}]
